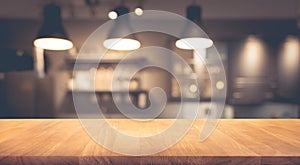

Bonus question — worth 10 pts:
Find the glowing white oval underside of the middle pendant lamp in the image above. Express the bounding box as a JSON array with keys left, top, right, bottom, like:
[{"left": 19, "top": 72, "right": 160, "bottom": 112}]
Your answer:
[{"left": 103, "top": 38, "right": 141, "bottom": 50}]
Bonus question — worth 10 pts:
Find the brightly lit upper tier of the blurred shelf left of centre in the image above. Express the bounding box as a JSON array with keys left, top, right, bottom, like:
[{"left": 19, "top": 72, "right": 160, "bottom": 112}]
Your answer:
[{"left": 69, "top": 59, "right": 145, "bottom": 91}]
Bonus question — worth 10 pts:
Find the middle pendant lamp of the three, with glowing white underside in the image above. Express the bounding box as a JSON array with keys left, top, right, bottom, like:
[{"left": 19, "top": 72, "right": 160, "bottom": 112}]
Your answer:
[{"left": 103, "top": 6, "right": 141, "bottom": 51}]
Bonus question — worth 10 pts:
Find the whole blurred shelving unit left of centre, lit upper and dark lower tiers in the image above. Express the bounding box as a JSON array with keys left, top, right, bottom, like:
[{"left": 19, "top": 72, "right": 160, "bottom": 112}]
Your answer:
[{"left": 68, "top": 58, "right": 149, "bottom": 115}]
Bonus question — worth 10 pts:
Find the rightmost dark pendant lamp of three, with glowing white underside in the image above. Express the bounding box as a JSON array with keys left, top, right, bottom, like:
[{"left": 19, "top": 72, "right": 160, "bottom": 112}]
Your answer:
[{"left": 175, "top": 5, "right": 213, "bottom": 50}]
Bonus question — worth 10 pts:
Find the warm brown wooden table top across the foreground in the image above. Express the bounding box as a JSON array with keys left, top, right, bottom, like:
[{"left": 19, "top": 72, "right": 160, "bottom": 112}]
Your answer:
[{"left": 0, "top": 119, "right": 300, "bottom": 164}]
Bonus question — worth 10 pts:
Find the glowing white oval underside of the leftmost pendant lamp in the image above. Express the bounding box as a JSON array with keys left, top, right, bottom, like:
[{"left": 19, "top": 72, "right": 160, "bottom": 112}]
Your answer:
[{"left": 33, "top": 38, "right": 73, "bottom": 50}]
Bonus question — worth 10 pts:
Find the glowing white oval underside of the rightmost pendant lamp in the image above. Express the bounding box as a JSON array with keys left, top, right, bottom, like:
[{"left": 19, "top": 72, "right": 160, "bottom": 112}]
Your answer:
[{"left": 175, "top": 37, "right": 213, "bottom": 50}]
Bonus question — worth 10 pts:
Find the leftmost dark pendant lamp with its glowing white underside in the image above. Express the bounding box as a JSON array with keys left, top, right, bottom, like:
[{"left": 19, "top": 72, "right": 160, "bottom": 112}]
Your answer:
[{"left": 33, "top": 3, "right": 73, "bottom": 50}]
